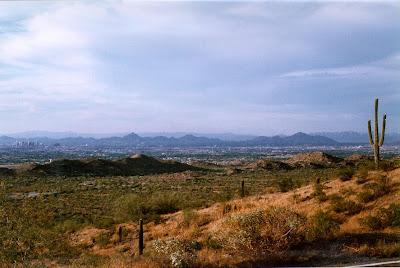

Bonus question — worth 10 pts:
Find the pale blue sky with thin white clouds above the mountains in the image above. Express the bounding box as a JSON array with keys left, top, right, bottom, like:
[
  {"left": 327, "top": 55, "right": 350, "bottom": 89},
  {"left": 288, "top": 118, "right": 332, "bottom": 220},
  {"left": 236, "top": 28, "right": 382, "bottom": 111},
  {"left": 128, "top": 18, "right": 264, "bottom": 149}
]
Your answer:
[{"left": 0, "top": 1, "right": 400, "bottom": 136}]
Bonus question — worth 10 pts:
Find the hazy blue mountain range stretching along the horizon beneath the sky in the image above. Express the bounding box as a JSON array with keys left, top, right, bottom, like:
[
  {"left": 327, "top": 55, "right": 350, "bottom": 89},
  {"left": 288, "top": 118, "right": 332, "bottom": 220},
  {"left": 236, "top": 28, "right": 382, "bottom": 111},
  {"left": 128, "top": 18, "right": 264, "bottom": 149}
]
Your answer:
[{"left": 0, "top": 132, "right": 400, "bottom": 147}]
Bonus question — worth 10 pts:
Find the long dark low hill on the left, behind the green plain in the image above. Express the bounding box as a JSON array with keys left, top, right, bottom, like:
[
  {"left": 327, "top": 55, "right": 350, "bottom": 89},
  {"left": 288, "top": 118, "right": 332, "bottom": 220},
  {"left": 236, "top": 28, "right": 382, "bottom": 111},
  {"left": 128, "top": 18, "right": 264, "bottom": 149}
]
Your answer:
[{"left": 25, "top": 154, "right": 200, "bottom": 177}]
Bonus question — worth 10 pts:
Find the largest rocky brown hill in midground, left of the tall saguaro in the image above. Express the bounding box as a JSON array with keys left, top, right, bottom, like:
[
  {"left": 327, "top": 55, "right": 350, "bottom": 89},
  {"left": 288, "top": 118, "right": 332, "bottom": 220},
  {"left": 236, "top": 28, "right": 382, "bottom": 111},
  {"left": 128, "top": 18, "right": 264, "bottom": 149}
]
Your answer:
[{"left": 286, "top": 152, "right": 343, "bottom": 168}]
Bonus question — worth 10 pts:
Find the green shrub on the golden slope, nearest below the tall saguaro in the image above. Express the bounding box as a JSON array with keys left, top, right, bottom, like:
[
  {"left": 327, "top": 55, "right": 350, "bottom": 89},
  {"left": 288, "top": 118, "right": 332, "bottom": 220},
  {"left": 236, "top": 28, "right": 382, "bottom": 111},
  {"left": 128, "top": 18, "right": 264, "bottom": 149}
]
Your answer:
[{"left": 357, "top": 176, "right": 390, "bottom": 203}]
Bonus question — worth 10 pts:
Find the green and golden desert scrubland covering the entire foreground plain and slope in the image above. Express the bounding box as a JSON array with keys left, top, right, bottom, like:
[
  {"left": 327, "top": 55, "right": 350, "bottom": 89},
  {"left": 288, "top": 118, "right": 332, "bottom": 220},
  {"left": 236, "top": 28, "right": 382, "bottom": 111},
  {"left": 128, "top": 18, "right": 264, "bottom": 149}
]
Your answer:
[{"left": 0, "top": 154, "right": 400, "bottom": 267}]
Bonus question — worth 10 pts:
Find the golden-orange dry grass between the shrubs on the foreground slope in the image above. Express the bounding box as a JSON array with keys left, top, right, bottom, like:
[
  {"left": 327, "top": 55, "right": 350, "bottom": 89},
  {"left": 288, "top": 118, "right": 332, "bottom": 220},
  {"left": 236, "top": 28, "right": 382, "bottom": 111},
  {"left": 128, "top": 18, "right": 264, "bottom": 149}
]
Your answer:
[{"left": 71, "top": 168, "right": 400, "bottom": 267}]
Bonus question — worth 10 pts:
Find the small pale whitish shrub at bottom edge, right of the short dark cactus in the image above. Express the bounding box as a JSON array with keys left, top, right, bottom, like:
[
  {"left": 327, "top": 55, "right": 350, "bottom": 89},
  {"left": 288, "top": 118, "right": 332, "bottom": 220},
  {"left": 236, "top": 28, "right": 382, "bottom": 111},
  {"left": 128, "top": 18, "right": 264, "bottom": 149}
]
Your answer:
[{"left": 153, "top": 238, "right": 201, "bottom": 267}]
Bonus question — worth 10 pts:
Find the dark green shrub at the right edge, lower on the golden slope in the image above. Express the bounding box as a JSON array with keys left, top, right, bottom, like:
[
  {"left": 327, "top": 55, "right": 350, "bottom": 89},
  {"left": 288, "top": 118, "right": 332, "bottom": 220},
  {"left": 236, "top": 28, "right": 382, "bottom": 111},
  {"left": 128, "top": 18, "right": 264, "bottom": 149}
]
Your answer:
[{"left": 361, "top": 204, "right": 400, "bottom": 231}]
